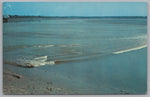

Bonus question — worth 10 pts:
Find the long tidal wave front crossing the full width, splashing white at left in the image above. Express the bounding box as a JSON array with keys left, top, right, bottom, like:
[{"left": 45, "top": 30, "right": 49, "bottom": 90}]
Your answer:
[{"left": 4, "top": 45, "right": 147, "bottom": 68}]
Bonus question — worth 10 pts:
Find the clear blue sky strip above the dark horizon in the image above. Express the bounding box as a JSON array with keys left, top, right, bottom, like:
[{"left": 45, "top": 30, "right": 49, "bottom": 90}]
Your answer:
[{"left": 3, "top": 2, "right": 147, "bottom": 16}]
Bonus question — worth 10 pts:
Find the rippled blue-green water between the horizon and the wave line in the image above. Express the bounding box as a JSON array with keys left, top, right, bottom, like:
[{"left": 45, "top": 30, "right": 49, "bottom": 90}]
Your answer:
[{"left": 3, "top": 18, "right": 147, "bottom": 65}]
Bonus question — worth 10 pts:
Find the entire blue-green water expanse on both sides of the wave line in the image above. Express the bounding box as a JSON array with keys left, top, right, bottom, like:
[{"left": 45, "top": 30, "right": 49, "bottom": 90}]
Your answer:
[{"left": 3, "top": 18, "right": 147, "bottom": 94}]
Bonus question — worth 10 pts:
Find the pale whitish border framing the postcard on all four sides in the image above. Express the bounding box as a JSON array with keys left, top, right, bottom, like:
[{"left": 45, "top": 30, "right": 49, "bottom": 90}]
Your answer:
[{"left": 0, "top": 0, "right": 150, "bottom": 97}]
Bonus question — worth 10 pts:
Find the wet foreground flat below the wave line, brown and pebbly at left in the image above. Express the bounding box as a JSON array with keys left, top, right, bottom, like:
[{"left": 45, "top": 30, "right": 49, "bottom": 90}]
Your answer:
[{"left": 3, "top": 48, "right": 147, "bottom": 95}]
